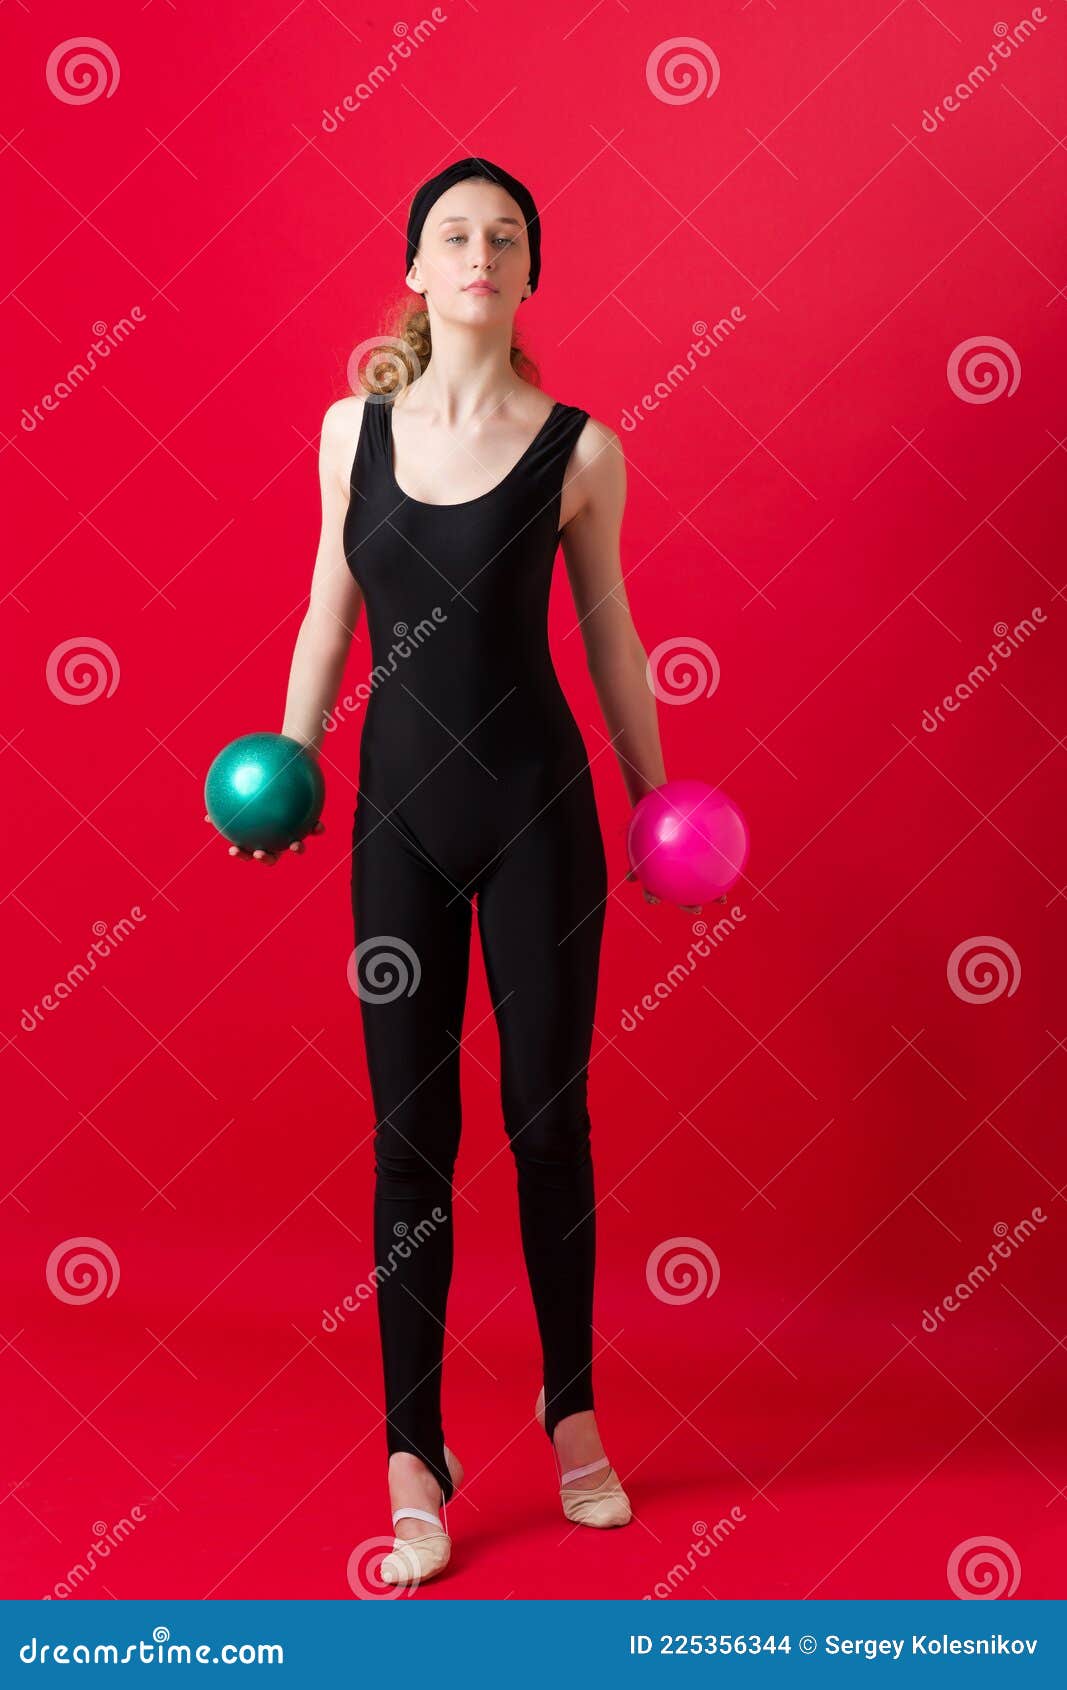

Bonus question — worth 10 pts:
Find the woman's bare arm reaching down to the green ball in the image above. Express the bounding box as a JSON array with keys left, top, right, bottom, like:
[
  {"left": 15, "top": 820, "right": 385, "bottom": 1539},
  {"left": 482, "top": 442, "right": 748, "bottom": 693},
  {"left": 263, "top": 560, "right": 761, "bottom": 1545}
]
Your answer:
[{"left": 281, "top": 397, "right": 364, "bottom": 755}]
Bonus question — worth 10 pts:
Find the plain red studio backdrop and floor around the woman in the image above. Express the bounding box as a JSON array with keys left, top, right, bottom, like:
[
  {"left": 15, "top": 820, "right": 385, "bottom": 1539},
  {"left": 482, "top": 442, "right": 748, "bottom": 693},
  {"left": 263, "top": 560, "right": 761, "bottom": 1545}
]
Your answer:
[{"left": 0, "top": 0, "right": 1067, "bottom": 1600}]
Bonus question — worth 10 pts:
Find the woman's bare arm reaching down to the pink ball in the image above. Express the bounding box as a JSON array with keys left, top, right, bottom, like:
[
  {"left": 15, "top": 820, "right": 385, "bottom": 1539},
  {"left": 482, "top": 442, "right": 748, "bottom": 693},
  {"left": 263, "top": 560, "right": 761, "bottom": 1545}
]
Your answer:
[{"left": 561, "top": 419, "right": 666, "bottom": 804}]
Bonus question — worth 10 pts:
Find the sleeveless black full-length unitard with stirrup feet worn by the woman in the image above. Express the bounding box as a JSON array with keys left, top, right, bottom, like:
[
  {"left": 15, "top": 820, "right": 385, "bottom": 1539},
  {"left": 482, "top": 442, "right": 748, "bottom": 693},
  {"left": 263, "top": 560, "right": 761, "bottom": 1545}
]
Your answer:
[{"left": 343, "top": 399, "right": 607, "bottom": 1499}]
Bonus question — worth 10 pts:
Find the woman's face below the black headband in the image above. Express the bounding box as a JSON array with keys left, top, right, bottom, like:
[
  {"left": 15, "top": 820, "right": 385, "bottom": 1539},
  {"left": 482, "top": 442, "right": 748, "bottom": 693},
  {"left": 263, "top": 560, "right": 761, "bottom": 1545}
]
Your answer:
[{"left": 408, "top": 181, "right": 529, "bottom": 323}]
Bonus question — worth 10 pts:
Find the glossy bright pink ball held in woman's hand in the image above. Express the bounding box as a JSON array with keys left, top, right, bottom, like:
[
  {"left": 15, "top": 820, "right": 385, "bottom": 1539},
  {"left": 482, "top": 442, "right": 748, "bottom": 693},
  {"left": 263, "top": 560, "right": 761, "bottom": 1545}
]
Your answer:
[{"left": 626, "top": 781, "right": 749, "bottom": 904}]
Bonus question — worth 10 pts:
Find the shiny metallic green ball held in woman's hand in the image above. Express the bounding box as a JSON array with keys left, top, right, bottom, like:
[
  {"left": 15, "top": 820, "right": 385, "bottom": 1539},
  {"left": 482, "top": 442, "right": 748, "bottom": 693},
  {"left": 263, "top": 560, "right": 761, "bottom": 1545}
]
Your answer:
[{"left": 205, "top": 733, "right": 326, "bottom": 852}]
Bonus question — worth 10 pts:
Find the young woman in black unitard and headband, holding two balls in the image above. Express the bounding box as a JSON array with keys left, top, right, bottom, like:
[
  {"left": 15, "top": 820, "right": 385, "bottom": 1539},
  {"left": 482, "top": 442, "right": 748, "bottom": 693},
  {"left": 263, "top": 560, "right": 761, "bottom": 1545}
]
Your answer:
[{"left": 219, "top": 159, "right": 700, "bottom": 1584}]
